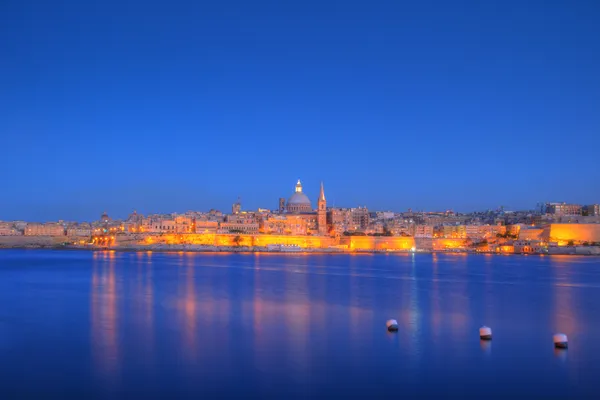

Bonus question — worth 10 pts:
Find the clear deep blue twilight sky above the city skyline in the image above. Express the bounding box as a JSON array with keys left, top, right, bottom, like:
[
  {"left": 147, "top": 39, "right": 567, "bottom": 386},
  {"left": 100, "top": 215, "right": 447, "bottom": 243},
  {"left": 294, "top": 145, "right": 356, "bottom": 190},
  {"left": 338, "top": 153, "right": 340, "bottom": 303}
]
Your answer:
[{"left": 0, "top": 0, "right": 600, "bottom": 221}]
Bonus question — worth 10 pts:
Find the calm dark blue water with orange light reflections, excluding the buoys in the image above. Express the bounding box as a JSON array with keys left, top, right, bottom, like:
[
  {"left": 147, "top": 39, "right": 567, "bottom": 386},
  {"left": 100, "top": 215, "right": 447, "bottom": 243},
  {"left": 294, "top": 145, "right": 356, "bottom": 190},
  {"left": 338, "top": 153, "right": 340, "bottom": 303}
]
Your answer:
[{"left": 0, "top": 250, "right": 600, "bottom": 399}]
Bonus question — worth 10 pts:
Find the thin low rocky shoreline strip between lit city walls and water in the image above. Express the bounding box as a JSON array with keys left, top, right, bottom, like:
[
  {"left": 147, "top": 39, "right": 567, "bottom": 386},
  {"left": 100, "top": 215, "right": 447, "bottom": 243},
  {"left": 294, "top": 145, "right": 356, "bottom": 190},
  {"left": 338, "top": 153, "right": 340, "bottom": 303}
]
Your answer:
[{"left": 0, "top": 245, "right": 600, "bottom": 257}]
